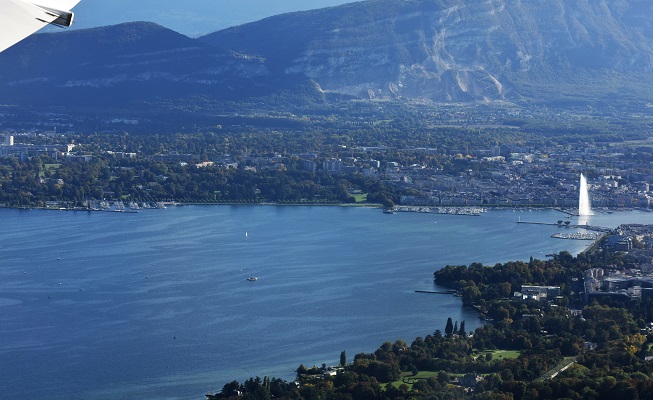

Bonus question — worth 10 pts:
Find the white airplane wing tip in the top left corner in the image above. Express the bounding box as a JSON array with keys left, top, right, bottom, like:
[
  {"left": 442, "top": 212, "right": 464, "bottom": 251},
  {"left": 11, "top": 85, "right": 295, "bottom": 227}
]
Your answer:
[{"left": 0, "top": 0, "right": 79, "bottom": 52}]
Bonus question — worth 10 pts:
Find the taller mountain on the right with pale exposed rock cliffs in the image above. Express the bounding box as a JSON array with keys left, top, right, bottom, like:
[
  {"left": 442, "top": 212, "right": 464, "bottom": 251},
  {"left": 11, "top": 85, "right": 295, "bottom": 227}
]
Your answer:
[{"left": 201, "top": 0, "right": 653, "bottom": 101}]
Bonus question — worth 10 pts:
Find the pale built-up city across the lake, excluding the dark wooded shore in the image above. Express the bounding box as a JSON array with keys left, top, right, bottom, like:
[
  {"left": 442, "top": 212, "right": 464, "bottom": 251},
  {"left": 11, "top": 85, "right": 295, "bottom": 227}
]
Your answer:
[{"left": 0, "top": 132, "right": 653, "bottom": 208}]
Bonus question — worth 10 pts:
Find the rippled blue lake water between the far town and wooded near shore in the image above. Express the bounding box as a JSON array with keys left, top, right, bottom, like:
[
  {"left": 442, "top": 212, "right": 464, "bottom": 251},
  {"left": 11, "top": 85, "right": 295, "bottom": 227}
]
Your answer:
[{"left": 0, "top": 206, "right": 653, "bottom": 400}]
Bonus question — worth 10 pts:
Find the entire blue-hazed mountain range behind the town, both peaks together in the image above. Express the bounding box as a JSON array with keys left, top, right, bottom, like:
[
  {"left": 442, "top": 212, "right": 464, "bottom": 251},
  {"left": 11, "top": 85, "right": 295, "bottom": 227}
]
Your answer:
[{"left": 0, "top": 0, "right": 653, "bottom": 110}]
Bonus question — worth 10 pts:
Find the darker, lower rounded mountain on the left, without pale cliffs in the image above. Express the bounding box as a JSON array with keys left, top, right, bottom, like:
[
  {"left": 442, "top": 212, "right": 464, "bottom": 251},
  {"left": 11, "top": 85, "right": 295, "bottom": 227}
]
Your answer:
[{"left": 0, "top": 22, "right": 271, "bottom": 106}]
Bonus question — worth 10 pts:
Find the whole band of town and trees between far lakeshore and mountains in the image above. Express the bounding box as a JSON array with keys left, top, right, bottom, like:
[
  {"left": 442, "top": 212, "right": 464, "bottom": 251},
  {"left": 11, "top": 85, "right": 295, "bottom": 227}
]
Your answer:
[{"left": 0, "top": 116, "right": 653, "bottom": 209}]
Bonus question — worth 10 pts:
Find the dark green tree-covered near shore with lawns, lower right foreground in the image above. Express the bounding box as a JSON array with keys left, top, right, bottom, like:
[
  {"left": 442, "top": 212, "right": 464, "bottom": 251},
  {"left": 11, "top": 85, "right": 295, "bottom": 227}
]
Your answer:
[{"left": 207, "top": 250, "right": 653, "bottom": 400}]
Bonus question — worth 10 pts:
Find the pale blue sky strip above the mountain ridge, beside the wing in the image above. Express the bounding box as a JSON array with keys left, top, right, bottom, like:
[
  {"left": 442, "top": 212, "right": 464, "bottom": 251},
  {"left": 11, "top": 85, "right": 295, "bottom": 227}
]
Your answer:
[{"left": 64, "top": 0, "right": 355, "bottom": 37}]
